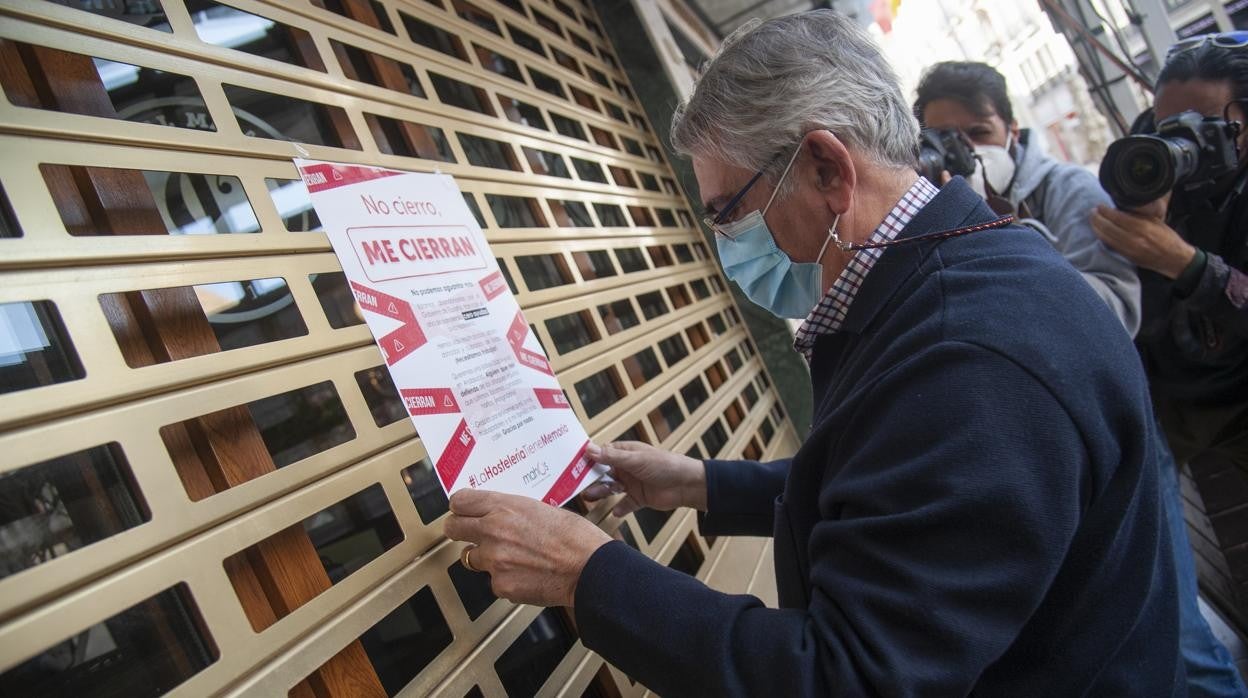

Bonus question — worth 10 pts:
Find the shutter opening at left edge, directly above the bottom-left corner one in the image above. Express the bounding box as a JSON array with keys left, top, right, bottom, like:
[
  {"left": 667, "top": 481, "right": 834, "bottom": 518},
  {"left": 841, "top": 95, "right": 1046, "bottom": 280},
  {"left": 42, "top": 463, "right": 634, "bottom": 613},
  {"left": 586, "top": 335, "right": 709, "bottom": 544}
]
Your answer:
[{"left": 0, "top": 443, "right": 151, "bottom": 579}]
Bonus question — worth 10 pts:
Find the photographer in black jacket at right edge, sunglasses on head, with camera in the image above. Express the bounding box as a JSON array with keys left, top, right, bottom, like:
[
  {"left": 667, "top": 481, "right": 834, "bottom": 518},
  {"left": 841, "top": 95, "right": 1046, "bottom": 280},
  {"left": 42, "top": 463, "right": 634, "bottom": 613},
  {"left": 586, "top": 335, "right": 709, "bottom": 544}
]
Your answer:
[{"left": 1091, "top": 31, "right": 1248, "bottom": 696}]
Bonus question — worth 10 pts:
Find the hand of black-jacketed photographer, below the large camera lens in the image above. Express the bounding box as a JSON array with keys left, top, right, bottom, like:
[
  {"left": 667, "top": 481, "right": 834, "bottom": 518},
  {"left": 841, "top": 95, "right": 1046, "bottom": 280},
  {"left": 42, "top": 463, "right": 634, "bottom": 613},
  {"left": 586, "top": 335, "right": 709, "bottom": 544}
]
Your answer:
[{"left": 1092, "top": 201, "right": 1196, "bottom": 280}]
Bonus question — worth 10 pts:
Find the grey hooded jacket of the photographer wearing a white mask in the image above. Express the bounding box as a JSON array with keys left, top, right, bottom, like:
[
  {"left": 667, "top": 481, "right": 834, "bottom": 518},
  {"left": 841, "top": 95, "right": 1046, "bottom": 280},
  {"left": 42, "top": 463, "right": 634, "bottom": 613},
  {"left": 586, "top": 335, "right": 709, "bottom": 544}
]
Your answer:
[{"left": 1006, "top": 129, "right": 1139, "bottom": 337}]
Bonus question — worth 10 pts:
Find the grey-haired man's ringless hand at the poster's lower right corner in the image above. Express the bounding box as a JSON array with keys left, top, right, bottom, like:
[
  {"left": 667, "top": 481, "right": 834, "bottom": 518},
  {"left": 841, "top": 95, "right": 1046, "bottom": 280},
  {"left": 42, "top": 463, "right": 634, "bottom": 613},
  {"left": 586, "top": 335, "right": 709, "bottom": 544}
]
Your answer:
[{"left": 583, "top": 441, "right": 706, "bottom": 516}]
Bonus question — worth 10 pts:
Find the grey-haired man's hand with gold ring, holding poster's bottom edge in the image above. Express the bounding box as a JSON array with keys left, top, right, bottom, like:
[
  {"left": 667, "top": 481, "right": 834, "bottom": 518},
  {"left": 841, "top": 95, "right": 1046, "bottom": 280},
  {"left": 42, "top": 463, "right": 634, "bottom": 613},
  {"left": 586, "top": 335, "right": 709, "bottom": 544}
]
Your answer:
[{"left": 444, "top": 489, "right": 612, "bottom": 608}]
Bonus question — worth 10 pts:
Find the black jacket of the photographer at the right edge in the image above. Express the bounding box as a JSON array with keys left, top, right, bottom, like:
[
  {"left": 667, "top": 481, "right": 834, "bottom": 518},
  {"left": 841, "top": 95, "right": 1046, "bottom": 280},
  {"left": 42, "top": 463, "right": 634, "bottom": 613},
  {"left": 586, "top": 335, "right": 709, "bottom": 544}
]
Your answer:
[{"left": 1136, "top": 172, "right": 1248, "bottom": 412}]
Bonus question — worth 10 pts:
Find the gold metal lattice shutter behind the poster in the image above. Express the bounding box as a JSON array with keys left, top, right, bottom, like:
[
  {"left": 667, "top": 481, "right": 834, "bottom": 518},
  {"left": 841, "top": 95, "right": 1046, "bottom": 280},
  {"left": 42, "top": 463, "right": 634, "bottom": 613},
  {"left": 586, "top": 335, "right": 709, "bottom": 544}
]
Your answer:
[{"left": 0, "top": 0, "right": 796, "bottom": 696}]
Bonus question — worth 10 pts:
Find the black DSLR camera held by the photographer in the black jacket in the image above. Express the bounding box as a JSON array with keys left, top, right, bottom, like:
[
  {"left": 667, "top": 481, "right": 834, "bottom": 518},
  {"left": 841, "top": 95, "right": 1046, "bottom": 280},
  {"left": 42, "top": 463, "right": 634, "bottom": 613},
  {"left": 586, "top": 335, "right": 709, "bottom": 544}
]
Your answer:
[{"left": 1101, "top": 111, "right": 1239, "bottom": 207}]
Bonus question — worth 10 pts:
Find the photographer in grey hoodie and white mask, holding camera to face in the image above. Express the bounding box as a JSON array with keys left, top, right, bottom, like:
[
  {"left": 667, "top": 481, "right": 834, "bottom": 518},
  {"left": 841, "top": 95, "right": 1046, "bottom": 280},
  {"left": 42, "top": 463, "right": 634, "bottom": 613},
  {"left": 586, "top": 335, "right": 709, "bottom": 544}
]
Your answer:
[{"left": 915, "top": 61, "right": 1139, "bottom": 335}]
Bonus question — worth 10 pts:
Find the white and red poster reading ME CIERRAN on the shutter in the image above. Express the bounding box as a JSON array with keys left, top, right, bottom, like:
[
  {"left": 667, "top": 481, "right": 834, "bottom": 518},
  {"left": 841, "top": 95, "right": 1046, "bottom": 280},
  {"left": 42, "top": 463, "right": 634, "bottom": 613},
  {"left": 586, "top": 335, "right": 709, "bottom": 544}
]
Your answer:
[{"left": 295, "top": 160, "right": 602, "bottom": 506}]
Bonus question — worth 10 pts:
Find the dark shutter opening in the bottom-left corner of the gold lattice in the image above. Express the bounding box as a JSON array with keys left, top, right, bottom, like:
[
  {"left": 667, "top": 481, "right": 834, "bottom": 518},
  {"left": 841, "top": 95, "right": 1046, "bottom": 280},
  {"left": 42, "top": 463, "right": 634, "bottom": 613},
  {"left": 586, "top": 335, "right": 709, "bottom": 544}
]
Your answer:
[{"left": 0, "top": 584, "right": 218, "bottom": 698}]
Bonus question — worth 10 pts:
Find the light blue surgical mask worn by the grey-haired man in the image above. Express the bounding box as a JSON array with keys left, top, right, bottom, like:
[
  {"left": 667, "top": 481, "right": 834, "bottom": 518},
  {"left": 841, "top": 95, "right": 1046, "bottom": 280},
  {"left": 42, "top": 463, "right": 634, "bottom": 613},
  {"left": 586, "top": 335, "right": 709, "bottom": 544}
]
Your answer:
[{"left": 715, "top": 145, "right": 840, "bottom": 320}]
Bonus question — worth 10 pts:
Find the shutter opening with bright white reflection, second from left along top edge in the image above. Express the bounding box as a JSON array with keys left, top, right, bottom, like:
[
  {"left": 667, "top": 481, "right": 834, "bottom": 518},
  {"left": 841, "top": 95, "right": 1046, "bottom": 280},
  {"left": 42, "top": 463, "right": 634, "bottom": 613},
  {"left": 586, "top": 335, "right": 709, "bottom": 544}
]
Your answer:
[{"left": 185, "top": 0, "right": 324, "bottom": 72}]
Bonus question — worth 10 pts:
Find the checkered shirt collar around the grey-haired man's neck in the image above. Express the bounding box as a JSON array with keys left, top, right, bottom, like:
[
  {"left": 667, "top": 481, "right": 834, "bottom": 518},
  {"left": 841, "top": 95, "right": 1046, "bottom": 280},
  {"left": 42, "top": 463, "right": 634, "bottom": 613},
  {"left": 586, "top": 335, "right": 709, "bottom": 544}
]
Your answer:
[{"left": 792, "top": 177, "right": 938, "bottom": 362}]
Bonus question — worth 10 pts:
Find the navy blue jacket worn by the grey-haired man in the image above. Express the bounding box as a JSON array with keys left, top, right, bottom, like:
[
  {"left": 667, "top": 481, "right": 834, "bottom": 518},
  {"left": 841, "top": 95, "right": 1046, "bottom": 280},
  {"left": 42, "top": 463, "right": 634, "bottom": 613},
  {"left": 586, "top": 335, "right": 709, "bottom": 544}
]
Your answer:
[{"left": 575, "top": 180, "right": 1186, "bottom": 697}]
